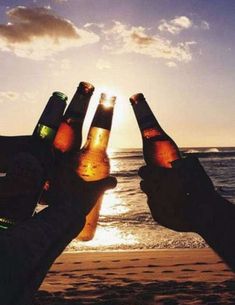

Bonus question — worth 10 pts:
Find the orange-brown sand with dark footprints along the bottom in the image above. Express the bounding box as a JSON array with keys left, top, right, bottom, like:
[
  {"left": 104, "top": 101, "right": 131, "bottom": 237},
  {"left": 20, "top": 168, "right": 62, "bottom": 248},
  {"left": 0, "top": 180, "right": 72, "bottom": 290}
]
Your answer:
[{"left": 35, "top": 249, "right": 235, "bottom": 305}]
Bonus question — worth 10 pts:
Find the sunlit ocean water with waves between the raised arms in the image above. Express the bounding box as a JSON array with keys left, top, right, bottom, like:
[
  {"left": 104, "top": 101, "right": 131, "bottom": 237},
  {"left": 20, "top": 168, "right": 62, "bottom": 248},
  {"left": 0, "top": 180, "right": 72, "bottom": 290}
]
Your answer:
[{"left": 67, "top": 147, "right": 235, "bottom": 252}]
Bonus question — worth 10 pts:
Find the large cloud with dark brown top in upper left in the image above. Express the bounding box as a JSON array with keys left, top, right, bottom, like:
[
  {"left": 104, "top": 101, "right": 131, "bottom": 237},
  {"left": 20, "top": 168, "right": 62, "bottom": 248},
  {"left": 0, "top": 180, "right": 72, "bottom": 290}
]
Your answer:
[{"left": 0, "top": 6, "right": 99, "bottom": 59}]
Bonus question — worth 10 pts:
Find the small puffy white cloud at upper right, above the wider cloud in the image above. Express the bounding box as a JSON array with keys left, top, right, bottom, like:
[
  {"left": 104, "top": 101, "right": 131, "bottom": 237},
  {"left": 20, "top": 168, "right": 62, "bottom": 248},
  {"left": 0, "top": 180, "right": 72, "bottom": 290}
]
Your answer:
[{"left": 158, "top": 16, "right": 193, "bottom": 34}]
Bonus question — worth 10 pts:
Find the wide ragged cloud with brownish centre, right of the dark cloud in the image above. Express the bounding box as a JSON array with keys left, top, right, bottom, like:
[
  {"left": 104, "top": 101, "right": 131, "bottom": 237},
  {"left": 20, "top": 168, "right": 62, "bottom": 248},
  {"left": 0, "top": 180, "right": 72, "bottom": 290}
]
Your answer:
[{"left": 103, "top": 21, "right": 196, "bottom": 63}]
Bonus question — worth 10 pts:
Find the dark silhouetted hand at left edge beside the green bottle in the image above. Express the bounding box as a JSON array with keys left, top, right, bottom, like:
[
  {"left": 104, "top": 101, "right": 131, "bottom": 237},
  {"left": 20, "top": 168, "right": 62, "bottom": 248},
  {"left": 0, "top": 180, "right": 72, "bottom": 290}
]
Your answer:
[{"left": 0, "top": 136, "right": 54, "bottom": 222}]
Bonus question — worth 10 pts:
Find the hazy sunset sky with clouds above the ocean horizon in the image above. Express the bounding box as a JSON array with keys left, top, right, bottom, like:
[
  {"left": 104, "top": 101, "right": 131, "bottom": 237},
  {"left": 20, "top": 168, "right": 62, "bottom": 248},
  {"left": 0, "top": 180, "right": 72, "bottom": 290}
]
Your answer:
[{"left": 0, "top": 0, "right": 235, "bottom": 148}]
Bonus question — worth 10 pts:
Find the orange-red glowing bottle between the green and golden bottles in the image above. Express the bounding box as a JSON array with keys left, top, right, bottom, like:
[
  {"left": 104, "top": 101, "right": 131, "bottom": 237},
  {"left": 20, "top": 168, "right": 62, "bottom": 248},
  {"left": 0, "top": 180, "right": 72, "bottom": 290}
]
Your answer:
[{"left": 53, "top": 82, "right": 95, "bottom": 154}]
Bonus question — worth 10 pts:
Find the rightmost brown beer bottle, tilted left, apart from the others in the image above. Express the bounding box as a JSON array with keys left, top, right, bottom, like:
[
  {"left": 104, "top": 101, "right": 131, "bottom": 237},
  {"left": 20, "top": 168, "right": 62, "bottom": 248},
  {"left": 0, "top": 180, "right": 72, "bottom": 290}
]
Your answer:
[{"left": 130, "top": 93, "right": 181, "bottom": 168}]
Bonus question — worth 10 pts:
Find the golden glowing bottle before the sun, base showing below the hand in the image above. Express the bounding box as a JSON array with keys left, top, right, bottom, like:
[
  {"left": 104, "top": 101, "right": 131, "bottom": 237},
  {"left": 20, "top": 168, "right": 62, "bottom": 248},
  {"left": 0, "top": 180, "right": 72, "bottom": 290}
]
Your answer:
[{"left": 76, "top": 93, "right": 116, "bottom": 241}]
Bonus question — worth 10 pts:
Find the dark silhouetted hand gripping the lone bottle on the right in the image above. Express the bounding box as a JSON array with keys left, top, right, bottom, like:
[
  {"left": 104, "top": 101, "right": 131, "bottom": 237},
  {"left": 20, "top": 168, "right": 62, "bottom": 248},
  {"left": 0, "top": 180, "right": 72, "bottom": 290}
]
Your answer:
[{"left": 139, "top": 157, "right": 216, "bottom": 232}]
